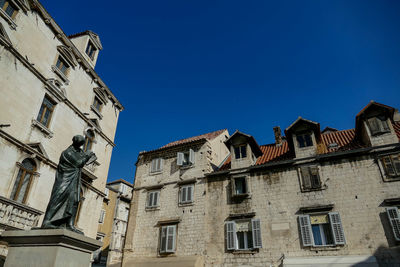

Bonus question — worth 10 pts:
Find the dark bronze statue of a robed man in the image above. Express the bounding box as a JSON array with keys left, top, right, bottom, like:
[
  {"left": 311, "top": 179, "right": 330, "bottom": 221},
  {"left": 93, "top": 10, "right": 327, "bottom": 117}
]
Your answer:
[{"left": 42, "top": 135, "right": 96, "bottom": 234}]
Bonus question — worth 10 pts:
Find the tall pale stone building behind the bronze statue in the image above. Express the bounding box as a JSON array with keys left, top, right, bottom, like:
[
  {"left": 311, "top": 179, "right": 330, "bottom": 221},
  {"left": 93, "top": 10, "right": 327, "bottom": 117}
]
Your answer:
[{"left": 0, "top": 0, "right": 123, "bottom": 264}]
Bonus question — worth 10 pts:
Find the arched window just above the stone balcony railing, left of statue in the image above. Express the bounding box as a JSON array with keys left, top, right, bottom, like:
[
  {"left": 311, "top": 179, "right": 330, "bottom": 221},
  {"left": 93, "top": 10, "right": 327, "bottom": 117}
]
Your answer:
[{"left": 11, "top": 159, "right": 36, "bottom": 203}]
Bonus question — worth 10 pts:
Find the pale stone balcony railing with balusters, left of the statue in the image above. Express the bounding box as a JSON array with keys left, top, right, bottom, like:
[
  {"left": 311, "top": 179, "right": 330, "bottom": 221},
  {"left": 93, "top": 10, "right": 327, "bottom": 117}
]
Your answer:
[{"left": 0, "top": 196, "right": 43, "bottom": 230}]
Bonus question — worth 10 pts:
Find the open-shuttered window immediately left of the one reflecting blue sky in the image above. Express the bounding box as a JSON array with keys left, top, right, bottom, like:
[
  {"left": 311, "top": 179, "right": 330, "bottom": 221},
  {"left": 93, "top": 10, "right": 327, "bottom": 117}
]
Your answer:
[{"left": 225, "top": 219, "right": 262, "bottom": 250}]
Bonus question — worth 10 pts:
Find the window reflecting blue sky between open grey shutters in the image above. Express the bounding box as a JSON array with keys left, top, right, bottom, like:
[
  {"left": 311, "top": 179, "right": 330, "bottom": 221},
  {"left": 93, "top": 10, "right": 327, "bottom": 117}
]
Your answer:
[{"left": 298, "top": 212, "right": 346, "bottom": 247}]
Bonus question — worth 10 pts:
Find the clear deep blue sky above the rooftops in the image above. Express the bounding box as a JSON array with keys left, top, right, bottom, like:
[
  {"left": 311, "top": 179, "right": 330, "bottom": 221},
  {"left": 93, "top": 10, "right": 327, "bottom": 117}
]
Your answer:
[{"left": 42, "top": 0, "right": 400, "bottom": 182}]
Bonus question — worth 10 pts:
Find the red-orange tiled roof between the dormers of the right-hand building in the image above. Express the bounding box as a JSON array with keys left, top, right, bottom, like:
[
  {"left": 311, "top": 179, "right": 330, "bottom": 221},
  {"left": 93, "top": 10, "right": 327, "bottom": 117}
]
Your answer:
[{"left": 219, "top": 126, "right": 400, "bottom": 171}]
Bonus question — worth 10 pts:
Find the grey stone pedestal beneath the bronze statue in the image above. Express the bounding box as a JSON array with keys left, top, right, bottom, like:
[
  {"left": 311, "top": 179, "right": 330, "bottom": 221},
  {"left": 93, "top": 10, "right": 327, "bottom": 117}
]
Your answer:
[{"left": 1, "top": 229, "right": 102, "bottom": 267}]
